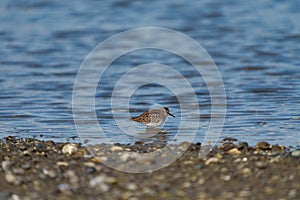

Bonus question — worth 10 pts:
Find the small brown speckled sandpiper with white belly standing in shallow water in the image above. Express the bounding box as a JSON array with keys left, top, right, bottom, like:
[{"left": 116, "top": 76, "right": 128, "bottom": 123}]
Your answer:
[{"left": 131, "top": 107, "right": 175, "bottom": 127}]
